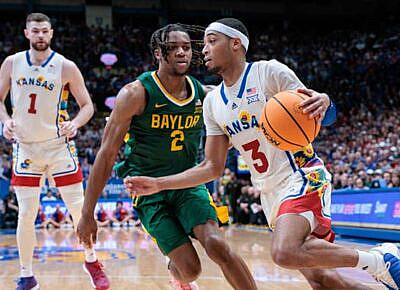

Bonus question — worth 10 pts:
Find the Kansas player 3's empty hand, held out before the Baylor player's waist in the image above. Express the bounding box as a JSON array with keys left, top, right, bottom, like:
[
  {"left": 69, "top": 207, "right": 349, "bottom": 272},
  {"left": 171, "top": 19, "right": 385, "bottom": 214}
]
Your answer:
[{"left": 124, "top": 176, "right": 161, "bottom": 195}]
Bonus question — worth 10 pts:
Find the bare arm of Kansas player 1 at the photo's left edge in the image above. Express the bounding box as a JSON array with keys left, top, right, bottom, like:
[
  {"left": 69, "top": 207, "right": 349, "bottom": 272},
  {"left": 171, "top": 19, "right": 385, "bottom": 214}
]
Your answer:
[{"left": 0, "top": 56, "right": 15, "bottom": 140}]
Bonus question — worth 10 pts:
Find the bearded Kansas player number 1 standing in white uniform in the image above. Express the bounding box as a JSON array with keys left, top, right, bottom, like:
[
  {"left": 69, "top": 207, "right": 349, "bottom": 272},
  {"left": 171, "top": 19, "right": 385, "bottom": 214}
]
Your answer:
[{"left": 0, "top": 13, "right": 109, "bottom": 290}]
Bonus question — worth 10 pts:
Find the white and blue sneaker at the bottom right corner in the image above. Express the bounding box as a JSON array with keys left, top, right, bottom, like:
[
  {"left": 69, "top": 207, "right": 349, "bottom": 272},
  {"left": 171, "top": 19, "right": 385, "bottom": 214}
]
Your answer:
[{"left": 369, "top": 243, "right": 400, "bottom": 290}]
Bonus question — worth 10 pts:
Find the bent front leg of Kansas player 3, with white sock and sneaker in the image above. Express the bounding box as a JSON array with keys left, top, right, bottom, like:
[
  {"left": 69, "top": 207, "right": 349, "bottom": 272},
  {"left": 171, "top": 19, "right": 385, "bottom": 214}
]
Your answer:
[{"left": 271, "top": 214, "right": 400, "bottom": 289}]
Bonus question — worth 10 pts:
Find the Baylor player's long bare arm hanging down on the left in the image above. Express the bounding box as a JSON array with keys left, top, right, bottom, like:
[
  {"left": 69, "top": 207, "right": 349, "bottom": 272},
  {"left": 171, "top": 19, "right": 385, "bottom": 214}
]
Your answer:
[{"left": 77, "top": 81, "right": 146, "bottom": 245}]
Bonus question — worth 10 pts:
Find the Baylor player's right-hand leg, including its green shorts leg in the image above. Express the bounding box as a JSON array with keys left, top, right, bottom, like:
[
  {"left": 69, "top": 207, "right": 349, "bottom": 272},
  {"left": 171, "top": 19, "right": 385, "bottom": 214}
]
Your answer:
[{"left": 172, "top": 186, "right": 257, "bottom": 290}]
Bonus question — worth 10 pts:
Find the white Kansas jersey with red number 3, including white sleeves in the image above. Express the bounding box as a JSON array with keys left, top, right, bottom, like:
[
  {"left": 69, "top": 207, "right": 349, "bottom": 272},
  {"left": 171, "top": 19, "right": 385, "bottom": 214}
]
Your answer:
[{"left": 204, "top": 60, "right": 323, "bottom": 192}]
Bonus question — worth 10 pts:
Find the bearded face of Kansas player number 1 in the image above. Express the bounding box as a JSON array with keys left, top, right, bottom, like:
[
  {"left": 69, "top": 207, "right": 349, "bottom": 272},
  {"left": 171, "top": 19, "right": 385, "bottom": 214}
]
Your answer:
[{"left": 24, "top": 21, "right": 53, "bottom": 51}]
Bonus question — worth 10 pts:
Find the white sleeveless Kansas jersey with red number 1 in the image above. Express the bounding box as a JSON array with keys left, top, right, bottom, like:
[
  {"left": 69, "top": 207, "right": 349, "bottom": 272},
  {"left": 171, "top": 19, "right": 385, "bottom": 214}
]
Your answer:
[{"left": 11, "top": 51, "right": 68, "bottom": 143}]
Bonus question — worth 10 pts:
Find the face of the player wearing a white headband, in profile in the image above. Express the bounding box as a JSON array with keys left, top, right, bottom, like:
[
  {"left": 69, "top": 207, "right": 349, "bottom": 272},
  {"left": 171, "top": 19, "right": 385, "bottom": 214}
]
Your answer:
[{"left": 203, "top": 31, "right": 232, "bottom": 73}]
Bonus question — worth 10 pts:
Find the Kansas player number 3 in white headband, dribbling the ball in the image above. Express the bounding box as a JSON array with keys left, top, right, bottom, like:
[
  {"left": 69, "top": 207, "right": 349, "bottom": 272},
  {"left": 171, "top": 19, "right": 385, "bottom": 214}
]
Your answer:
[{"left": 125, "top": 18, "right": 400, "bottom": 289}]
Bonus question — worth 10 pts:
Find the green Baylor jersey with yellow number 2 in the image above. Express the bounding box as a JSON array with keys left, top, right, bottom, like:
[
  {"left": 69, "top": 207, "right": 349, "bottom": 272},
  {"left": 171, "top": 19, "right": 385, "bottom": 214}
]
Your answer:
[{"left": 117, "top": 71, "right": 204, "bottom": 177}]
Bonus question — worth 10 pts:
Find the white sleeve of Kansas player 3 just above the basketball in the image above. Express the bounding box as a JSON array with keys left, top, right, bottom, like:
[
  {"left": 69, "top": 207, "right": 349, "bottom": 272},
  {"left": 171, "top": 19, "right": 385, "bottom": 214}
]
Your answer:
[{"left": 260, "top": 59, "right": 306, "bottom": 96}]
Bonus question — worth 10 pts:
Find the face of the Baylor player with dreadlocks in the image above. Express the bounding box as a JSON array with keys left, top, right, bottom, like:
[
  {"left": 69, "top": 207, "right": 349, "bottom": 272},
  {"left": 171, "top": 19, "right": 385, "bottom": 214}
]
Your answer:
[{"left": 160, "top": 31, "right": 192, "bottom": 76}]
